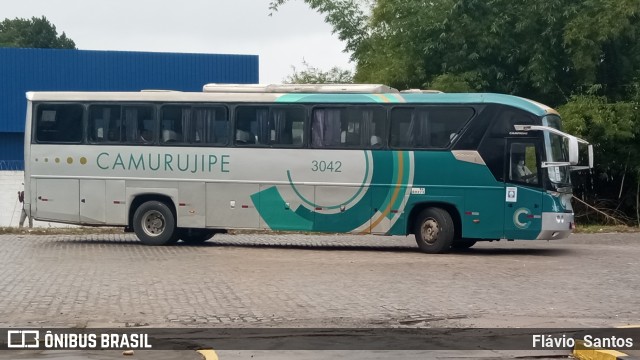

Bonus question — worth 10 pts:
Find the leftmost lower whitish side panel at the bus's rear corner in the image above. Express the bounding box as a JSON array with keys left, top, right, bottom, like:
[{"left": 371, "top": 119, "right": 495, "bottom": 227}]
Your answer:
[{"left": 35, "top": 179, "right": 80, "bottom": 223}]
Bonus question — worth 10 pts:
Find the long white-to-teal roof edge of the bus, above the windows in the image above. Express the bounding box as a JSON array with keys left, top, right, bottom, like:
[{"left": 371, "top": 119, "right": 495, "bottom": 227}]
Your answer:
[{"left": 26, "top": 84, "right": 558, "bottom": 116}]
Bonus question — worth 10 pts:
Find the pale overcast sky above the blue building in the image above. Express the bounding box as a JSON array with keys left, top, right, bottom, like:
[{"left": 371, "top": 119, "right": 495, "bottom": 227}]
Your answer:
[{"left": 0, "top": 0, "right": 353, "bottom": 83}]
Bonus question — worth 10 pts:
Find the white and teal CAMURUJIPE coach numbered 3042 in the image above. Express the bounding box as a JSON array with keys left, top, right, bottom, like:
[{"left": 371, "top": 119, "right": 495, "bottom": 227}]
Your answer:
[{"left": 24, "top": 84, "right": 593, "bottom": 253}]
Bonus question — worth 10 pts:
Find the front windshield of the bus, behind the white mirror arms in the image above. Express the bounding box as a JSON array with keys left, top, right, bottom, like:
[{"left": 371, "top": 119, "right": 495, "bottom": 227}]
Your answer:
[{"left": 542, "top": 115, "right": 571, "bottom": 190}]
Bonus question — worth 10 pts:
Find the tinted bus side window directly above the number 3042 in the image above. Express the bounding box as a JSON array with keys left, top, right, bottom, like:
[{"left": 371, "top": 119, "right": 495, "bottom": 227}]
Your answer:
[{"left": 311, "top": 106, "right": 386, "bottom": 149}]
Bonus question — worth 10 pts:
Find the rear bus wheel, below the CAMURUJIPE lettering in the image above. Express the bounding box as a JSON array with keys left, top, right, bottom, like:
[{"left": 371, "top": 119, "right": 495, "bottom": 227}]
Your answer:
[{"left": 133, "top": 201, "right": 177, "bottom": 245}]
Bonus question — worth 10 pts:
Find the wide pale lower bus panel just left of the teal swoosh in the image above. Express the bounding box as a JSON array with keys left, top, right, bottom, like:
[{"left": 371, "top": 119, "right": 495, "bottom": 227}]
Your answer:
[{"left": 206, "top": 183, "right": 260, "bottom": 229}]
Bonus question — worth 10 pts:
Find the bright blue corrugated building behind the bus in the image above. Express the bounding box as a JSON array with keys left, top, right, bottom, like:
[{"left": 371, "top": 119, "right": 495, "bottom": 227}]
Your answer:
[{"left": 0, "top": 48, "right": 259, "bottom": 170}]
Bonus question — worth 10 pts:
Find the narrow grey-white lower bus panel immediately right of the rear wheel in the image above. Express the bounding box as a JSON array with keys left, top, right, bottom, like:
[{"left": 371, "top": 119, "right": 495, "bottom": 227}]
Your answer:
[{"left": 177, "top": 181, "right": 206, "bottom": 228}]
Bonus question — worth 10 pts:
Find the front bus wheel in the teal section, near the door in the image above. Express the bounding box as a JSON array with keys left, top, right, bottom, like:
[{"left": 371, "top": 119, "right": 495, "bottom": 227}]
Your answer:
[{"left": 413, "top": 208, "right": 454, "bottom": 254}]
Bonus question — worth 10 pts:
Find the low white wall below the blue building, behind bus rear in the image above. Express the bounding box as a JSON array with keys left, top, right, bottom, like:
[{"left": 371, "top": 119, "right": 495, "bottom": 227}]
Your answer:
[{"left": 0, "top": 171, "right": 70, "bottom": 227}]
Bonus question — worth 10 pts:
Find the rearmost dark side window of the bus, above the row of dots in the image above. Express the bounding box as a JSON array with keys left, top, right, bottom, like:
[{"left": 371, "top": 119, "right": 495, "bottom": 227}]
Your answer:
[{"left": 36, "top": 104, "right": 84, "bottom": 143}]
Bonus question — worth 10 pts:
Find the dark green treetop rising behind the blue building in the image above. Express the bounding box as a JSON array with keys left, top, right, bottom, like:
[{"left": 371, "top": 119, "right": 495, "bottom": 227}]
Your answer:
[{"left": 0, "top": 16, "right": 76, "bottom": 49}]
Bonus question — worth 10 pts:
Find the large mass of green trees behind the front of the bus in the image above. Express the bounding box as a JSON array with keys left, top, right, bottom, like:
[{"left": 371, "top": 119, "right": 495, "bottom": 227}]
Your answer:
[{"left": 271, "top": 0, "right": 640, "bottom": 224}]
